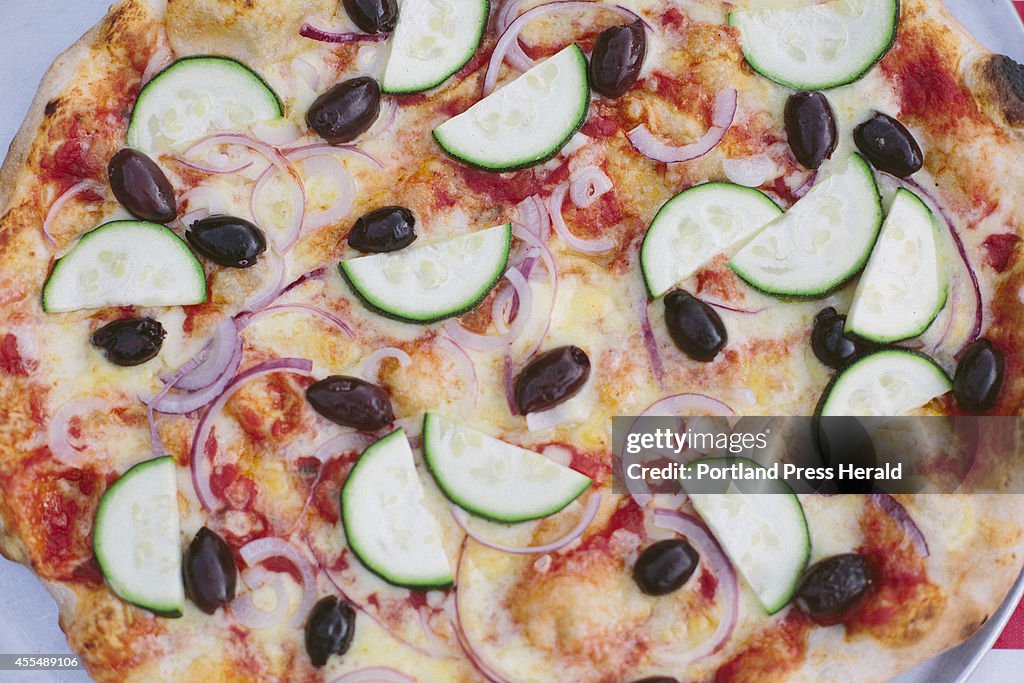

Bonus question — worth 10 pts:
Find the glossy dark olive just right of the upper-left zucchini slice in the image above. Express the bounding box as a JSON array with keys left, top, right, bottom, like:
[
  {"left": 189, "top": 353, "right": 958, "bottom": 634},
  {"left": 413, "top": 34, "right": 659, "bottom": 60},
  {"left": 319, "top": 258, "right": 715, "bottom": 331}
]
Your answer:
[{"left": 306, "top": 76, "right": 381, "bottom": 144}]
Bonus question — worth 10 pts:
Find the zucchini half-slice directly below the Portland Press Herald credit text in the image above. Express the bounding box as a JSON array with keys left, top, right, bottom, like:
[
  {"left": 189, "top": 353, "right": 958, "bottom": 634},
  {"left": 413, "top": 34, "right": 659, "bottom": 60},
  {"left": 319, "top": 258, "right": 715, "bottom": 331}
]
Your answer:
[{"left": 682, "top": 458, "right": 811, "bottom": 614}]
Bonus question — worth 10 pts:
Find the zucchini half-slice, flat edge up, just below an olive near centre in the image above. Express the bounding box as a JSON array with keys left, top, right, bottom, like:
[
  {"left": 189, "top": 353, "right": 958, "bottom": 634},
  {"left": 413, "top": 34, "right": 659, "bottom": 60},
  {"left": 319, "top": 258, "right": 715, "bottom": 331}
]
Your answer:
[{"left": 339, "top": 223, "right": 512, "bottom": 323}]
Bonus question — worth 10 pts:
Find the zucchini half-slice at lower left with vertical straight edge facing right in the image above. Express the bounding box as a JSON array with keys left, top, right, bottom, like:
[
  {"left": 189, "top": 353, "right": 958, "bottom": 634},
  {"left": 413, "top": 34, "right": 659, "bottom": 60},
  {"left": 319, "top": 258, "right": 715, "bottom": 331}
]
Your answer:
[{"left": 92, "top": 456, "right": 185, "bottom": 616}]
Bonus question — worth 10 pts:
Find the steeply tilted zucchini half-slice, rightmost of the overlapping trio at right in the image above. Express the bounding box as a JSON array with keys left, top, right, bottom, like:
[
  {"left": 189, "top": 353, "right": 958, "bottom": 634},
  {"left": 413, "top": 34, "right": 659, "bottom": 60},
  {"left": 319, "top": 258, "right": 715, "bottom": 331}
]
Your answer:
[{"left": 846, "top": 188, "right": 948, "bottom": 344}]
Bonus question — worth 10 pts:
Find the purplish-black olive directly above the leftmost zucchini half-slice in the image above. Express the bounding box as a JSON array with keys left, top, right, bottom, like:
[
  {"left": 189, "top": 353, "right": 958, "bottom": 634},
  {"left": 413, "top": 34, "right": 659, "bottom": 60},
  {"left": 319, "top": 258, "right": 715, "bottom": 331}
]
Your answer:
[{"left": 106, "top": 147, "right": 178, "bottom": 223}]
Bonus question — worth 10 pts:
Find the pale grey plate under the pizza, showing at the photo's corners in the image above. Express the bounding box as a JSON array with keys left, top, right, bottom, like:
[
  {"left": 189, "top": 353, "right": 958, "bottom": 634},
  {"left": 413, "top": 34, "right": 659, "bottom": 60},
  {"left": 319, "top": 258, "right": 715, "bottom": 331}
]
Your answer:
[{"left": 0, "top": 0, "right": 1024, "bottom": 683}]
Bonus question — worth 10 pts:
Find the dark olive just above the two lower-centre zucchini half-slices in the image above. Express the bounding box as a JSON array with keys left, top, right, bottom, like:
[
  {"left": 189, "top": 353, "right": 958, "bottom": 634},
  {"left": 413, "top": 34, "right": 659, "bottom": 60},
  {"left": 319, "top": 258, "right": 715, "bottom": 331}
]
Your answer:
[{"left": 306, "top": 375, "right": 394, "bottom": 432}]
